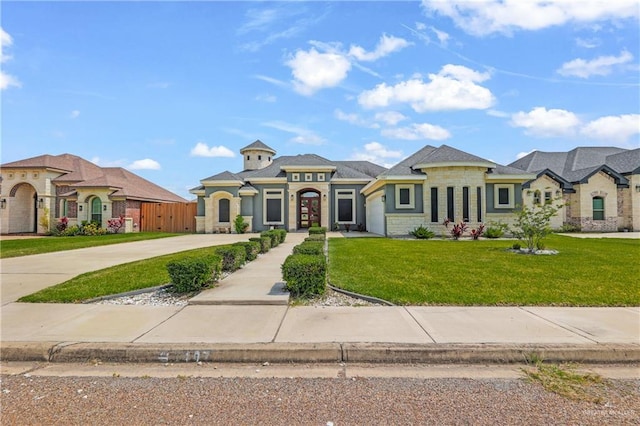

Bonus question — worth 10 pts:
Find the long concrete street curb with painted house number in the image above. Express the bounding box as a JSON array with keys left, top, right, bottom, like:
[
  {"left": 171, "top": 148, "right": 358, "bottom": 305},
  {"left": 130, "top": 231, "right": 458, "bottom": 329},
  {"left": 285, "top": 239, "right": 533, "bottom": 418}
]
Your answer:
[{"left": 0, "top": 342, "right": 640, "bottom": 364}]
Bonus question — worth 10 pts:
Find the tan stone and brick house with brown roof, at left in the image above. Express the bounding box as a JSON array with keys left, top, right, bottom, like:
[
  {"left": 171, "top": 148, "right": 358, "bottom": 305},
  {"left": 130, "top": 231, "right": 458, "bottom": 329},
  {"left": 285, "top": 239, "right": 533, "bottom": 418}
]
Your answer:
[{"left": 0, "top": 154, "right": 186, "bottom": 234}]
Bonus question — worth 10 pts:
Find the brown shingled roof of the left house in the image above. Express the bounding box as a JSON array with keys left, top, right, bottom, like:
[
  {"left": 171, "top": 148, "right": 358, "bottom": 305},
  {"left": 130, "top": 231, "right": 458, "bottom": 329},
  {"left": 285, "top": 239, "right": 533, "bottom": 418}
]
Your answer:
[{"left": 0, "top": 154, "right": 187, "bottom": 203}]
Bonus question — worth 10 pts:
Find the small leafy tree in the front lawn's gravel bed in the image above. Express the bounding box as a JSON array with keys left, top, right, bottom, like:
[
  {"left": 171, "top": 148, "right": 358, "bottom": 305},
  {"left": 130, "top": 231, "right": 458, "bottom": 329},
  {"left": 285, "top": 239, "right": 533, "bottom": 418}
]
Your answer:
[{"left": 509, "top": 199, "right": 564, "bottom": 253}]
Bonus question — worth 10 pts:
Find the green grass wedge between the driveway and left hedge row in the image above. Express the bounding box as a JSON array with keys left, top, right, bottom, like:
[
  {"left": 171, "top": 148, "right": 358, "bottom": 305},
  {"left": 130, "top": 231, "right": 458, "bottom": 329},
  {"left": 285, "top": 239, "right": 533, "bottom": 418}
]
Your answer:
[{"left": 18, "top": 246, "right": 222, "bottom": 303}]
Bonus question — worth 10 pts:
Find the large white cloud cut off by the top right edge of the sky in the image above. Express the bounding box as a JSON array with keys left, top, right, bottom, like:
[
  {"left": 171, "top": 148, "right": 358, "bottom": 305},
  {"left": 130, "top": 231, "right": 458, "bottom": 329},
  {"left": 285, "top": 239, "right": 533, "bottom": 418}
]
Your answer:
[{"left": 422, "top": 0, "right": 640, "bottom": 36}]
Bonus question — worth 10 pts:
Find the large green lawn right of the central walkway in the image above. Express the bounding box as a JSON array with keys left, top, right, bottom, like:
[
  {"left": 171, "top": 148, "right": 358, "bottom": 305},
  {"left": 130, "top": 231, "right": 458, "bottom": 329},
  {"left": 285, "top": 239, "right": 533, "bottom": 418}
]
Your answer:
[{"left": 329, "top": 235, "right": 640, "bottom": 306}]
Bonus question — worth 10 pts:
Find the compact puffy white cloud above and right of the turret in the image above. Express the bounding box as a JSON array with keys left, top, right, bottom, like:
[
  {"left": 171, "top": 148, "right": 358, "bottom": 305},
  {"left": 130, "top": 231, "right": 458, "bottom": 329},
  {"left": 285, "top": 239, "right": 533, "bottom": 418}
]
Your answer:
[{"left": 286, "top": 47, "right": 351, "bottom": 96}]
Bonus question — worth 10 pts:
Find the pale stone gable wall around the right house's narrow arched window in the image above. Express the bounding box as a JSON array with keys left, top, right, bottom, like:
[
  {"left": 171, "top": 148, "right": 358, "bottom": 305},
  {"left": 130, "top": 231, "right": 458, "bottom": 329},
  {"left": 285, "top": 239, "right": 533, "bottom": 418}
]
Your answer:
[{"left": 567, "top": 172, "right": 618, "bottom": 232}]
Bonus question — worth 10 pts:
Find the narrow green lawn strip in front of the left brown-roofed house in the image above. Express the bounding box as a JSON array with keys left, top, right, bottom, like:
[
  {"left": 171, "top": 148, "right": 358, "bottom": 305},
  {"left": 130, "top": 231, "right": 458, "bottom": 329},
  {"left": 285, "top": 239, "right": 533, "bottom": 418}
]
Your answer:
[{"left": 0, "top": 232, "right": 182, "bottom": 259}]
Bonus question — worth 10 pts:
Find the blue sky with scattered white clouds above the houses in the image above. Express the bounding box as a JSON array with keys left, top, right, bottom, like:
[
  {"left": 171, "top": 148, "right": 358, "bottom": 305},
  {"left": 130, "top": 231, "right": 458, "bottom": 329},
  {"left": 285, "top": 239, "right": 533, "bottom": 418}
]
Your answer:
[{"left": 0, "top": 0, "right": 640, "bottom": 198}]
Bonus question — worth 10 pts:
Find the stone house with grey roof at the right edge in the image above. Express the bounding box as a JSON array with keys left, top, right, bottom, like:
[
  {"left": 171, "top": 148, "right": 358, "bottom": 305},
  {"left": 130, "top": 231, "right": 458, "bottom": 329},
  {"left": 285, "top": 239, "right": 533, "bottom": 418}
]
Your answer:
[{"left": 510, "top": 147, "right": 640, "bottom": 232}]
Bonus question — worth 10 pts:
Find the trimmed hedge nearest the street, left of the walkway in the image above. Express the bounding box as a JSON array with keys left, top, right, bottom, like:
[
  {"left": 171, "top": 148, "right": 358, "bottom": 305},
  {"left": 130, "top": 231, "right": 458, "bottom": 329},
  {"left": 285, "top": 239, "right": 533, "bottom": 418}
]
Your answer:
[{"left": 167, "top": 255, "right": 222, "bottom": 293}]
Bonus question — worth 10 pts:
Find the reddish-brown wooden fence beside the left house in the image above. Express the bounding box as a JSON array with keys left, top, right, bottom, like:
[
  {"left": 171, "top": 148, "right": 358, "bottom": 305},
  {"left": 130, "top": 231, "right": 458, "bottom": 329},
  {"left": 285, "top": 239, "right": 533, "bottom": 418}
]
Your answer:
[{"left": 140, "top": 203, "right": 197, "bottom": 233}]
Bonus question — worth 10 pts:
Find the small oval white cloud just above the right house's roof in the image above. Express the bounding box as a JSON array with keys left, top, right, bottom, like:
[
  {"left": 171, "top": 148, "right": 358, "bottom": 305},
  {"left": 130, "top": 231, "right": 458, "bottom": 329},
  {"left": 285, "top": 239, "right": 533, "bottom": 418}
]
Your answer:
[{"left": 511, "top": 107, "right": 580, "bottom": 137}]
